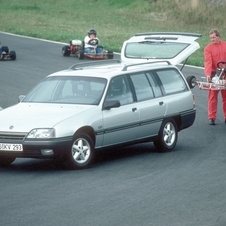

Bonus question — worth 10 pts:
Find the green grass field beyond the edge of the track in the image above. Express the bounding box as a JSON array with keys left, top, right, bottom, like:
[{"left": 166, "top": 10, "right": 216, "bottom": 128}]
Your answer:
[{"left": 0, "top": 0, "right": 226, "bottom": 66}]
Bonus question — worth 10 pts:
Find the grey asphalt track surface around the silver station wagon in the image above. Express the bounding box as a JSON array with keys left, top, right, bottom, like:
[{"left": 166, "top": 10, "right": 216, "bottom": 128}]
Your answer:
[{"left": 0, "top": 33, "right": 226, "bottom": 226}]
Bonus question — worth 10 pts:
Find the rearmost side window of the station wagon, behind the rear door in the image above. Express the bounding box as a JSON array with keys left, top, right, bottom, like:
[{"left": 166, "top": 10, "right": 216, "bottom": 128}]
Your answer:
[{"left": 156, "top": 68, "right": 188, "bottom": 94}]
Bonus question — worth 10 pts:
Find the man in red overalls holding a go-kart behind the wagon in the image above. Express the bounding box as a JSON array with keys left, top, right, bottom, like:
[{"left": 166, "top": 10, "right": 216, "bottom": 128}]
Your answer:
[{"left": 204, "top": 29, "right": 226, "bottom": 125}]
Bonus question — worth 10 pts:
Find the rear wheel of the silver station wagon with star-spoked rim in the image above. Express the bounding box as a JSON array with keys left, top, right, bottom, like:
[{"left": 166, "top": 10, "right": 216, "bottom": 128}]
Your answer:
[{"left": 154, "top": 119, "right": 178, "bottom": 152}]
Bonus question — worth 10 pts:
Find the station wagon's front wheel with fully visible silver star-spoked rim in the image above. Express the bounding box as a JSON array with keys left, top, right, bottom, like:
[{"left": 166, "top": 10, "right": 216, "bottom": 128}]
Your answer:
[{"left": 65, "top": 133, "right": 94, "bottom": 169}]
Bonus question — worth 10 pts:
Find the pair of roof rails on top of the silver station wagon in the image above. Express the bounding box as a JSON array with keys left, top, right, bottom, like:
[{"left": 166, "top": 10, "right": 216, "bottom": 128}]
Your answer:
[{"left": 69, "top": 59, "right": 171, "bottom": 71}]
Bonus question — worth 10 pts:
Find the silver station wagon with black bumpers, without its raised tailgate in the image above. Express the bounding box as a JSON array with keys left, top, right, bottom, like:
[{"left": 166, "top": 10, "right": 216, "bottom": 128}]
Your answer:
[{"left": 0, "top": 60, "right": 196, "bottom": 169}]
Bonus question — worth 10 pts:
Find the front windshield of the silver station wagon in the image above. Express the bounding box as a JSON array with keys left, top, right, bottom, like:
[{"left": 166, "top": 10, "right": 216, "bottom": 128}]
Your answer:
[{"left": 22, "top": 76, "right": 107, "bottom": 105}]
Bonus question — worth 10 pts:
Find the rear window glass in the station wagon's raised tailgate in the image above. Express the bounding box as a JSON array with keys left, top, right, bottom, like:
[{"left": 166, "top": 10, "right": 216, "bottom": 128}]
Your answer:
[{"left": 125, "top": 41, "right": 189, "bottom": 59}]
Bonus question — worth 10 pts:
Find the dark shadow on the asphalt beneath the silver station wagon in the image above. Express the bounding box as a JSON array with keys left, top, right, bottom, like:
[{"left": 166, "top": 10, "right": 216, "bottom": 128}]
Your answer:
[{"left": 0, "top": 142, "right": 177, "bottom": 172}]
